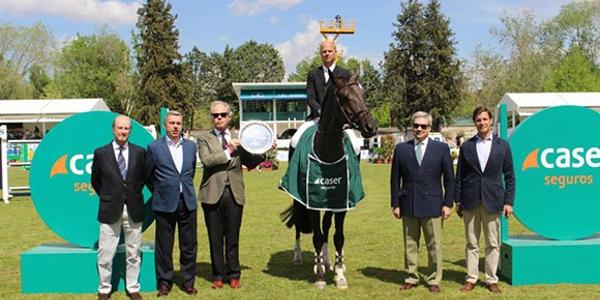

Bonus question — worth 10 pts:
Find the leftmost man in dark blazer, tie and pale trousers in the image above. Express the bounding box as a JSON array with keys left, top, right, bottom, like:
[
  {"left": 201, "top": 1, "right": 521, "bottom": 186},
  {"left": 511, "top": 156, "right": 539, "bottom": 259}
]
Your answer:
[{"left": 91, "top": 115, "right": 146, "bottom": 300}]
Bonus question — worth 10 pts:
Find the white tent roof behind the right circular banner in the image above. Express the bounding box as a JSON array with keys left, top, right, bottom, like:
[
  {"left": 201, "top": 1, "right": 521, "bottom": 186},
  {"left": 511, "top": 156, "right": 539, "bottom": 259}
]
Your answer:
[{"left": 500, "top": 93, "right": 600, "bottom": 127}]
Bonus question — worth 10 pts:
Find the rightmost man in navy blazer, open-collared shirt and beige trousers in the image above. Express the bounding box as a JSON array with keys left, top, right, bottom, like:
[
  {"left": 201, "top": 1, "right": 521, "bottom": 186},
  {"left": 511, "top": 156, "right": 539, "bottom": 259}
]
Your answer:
[{"left": 454, "top": 107, "right": 515, "bottom": 293}]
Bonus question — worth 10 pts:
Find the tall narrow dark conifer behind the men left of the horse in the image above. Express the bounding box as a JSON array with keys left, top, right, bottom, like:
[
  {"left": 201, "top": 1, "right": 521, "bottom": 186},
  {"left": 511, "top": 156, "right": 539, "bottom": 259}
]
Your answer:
[{"left": 135, "top": 0, "right": 193, "bottom": 124}]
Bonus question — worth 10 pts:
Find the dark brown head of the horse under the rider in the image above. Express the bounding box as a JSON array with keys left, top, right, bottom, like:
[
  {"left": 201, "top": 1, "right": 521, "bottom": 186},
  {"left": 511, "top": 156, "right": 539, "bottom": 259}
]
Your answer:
[{"left": 334, "top": 76, "right": 377, "bottom": 138}]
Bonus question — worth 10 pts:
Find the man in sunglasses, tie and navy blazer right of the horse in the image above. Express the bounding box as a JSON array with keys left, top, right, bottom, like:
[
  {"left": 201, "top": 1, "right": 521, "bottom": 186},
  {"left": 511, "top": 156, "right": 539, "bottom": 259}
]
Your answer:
[{"left": 391, "top": 112, "right": 454, "bottom": 293}]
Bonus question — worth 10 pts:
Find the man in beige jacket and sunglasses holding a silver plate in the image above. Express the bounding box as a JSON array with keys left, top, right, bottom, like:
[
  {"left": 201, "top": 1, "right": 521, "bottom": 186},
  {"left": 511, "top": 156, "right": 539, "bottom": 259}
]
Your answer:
[{"left": 198, "top": 101, "right": 265, "bottom": 289}]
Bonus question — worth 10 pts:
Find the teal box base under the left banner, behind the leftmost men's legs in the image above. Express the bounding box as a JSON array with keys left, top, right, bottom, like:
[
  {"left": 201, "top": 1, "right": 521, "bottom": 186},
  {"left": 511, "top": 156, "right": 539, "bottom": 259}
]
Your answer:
[{"left": 21, "top": 243, "right": 156, "bottom": 293}]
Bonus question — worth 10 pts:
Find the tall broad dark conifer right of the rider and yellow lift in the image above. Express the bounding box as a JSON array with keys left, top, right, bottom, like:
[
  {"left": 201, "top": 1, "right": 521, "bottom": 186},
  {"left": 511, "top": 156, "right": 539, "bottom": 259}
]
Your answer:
[{"left": 383, "top": 0, "right": 462, "bottom": 130}]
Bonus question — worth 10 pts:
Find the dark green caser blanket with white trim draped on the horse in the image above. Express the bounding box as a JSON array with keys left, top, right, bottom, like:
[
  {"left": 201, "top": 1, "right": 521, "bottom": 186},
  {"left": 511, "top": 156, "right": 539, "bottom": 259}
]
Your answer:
[{"left": 279, "top": 126, "right": 365, "bottom": 212}]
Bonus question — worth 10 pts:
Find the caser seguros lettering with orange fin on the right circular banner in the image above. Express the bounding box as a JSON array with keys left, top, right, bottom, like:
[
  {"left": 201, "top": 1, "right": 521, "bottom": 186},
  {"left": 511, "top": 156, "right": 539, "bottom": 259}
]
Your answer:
[{"left": 521, "top": 147, "right": 600, "bottom": 189}]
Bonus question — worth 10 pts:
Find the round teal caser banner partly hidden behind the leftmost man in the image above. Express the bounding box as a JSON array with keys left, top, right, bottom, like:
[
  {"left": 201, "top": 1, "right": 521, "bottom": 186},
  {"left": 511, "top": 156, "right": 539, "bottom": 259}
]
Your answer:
[{"left": 29, "top": 111, "right": 153, "bottom": 247}]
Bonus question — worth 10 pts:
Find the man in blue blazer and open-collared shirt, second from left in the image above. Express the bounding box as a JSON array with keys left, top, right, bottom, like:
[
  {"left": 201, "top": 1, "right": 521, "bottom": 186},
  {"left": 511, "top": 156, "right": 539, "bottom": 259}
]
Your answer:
[{"left": 146, "top": 110, "right": 198, "bottom": 297}]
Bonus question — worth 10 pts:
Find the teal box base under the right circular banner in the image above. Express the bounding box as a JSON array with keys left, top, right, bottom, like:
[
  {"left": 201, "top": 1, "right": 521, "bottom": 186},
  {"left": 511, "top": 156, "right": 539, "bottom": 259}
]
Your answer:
[{"left": 500, "top": 235, "right": 600, "bottom": 285}]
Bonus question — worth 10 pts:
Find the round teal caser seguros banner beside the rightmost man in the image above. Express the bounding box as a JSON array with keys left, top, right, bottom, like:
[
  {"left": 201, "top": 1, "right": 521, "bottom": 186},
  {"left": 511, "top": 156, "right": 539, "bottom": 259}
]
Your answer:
[{"left": 510, "top": 106, "right": 600, "bottom": 240}]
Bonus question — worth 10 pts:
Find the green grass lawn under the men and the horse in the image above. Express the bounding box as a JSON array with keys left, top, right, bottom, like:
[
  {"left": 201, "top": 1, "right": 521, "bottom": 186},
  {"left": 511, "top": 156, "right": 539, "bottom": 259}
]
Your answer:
[{"left": 0, "top": 162, "right": 600, "bottom": 299}]
